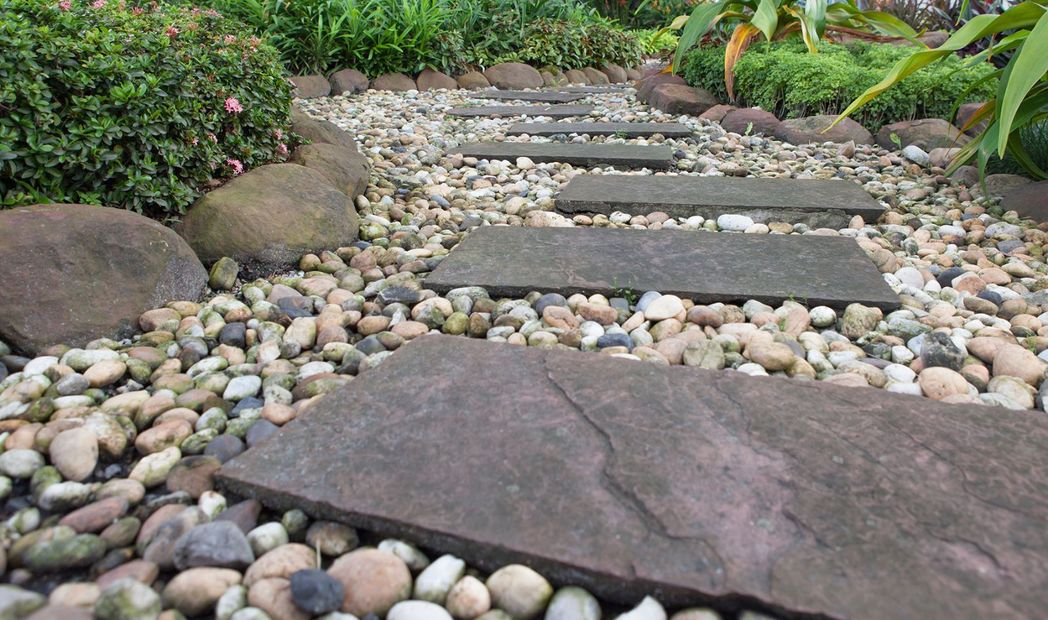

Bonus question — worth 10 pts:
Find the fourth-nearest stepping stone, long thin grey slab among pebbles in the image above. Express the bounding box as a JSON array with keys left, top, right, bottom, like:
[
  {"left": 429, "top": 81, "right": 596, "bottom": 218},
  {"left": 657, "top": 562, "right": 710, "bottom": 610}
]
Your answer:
[{"left": 451, "top": 142, "right": 673, "bottom": 170}]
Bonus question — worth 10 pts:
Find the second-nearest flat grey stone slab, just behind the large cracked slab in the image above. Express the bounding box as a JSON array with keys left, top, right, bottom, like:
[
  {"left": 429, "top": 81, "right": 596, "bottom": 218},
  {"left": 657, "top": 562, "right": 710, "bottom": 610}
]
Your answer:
[{"left": 425, "top": 226, "right": 899, "bottom": 310}]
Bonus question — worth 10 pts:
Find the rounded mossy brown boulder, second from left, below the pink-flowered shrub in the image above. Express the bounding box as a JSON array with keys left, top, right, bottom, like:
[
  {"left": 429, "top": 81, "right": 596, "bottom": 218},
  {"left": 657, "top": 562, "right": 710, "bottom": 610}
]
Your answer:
[{"left": 180, "top": 163, "right": 359, "bottom": 278}]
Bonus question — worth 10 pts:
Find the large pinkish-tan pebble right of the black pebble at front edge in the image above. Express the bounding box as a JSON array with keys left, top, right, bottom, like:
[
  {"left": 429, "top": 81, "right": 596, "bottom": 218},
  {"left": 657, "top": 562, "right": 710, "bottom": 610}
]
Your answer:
[{"left": 328, "top": 549, "right": 412, "bottom": 618}]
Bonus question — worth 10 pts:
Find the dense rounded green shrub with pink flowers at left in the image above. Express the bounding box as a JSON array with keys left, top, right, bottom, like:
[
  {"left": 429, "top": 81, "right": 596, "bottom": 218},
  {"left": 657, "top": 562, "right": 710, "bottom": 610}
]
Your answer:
[{"left": 0, "top": 0, "right": 291, "bottom": 218}]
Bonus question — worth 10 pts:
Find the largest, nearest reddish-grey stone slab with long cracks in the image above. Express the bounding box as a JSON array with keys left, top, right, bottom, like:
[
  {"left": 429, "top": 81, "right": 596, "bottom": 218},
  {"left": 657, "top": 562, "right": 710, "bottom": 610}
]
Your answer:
[{"left": 218, "top": 336, "right": 1048, "bottom": 620}]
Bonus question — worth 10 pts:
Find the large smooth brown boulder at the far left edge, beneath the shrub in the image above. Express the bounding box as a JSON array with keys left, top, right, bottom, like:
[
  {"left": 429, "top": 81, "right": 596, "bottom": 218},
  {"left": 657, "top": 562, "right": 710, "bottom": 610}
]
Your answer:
[{"left": 0, "top": 204, "right": 208, "bottom": 355}]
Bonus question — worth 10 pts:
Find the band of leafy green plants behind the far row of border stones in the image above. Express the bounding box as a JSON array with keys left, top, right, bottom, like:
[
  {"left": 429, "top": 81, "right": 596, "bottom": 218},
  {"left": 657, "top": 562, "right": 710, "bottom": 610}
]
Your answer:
[{"left": 175, "top": 0, "right": 641, "bottom": 78}]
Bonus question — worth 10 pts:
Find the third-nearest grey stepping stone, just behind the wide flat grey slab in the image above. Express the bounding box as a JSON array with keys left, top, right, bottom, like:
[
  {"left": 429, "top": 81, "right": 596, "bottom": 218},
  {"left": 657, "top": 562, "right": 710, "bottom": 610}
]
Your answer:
[{"left": 557, "top": 173, "right": 885, "bottom": 228}]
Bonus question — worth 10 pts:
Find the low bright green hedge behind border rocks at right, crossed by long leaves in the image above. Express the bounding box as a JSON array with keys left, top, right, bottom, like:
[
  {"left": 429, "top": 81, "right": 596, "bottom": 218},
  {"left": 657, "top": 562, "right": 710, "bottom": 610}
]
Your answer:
[{"left": 681, "top": 42, "right": 996, "bottom": 132}]
